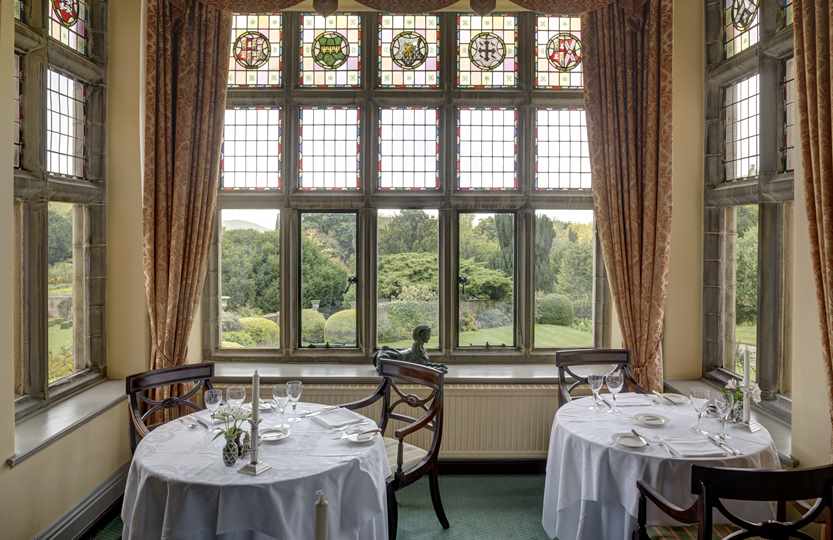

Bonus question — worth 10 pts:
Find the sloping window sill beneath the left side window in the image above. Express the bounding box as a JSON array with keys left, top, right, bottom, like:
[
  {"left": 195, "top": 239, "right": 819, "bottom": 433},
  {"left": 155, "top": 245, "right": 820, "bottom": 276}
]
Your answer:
[{"left": 6, "top": 380, "right": 126, "bottom": 467}]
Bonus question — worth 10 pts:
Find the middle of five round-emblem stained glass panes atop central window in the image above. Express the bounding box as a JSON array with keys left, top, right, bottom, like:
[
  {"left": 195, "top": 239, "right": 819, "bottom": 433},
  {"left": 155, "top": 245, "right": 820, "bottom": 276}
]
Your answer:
[{"left": 379, "top": 15, "right": 440, "bottom": 88}]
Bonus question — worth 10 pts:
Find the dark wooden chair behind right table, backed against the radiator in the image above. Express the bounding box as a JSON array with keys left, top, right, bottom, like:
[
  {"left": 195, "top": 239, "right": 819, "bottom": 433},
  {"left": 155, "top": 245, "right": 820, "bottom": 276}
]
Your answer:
[{"left": 555, "top": 349, "right": 646, "bottom": 407}]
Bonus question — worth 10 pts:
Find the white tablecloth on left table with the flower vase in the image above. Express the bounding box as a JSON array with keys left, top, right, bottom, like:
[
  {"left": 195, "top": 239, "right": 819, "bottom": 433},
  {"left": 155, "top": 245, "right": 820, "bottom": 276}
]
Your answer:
[{"left": 122, "top": 404, "right": 389, "bottom": 540}]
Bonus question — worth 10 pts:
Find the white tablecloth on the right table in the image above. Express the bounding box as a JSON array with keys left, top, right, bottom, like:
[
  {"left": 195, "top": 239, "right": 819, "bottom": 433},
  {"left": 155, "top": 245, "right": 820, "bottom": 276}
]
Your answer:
[{"left": 542, "top": 394, "right": 780, "bottom": 540}]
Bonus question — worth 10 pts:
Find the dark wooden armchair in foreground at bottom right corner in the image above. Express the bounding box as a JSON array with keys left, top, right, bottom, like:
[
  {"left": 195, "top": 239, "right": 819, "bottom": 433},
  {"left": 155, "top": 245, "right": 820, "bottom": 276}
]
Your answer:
[{"left": 633, "top": 465, "right": 833, "bottom": 540}]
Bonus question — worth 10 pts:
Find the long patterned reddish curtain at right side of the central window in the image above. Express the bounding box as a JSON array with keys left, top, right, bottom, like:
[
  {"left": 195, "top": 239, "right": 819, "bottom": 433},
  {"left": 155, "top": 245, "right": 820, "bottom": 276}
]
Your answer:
[{"left": 582, "top": 0, "right": 672, "bottom": 390}]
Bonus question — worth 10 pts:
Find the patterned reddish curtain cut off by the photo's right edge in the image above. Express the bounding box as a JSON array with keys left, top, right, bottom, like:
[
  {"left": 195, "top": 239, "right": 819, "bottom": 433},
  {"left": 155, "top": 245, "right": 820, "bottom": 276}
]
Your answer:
[{"left": 793, "top": 0, "right": 833, "bottom": 445}]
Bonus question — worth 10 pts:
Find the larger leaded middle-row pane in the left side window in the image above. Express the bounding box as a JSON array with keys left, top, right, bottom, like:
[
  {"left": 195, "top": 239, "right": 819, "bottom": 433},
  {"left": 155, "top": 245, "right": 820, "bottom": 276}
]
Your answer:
[{"left": 46, "top": 69, "right": 87, "bottom": 177}]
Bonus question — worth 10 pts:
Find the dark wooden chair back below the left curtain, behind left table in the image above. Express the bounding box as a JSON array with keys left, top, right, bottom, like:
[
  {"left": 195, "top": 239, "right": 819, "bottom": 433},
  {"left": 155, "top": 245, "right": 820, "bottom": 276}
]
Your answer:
[{"left": 125, "top": 363, "right": 214, "bottom": 450}]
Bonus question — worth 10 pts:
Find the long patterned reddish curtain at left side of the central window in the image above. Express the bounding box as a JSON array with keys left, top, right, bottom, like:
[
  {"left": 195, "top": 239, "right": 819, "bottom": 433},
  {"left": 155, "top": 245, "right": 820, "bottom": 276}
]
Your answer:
[{"left": 142, "top": 0, "right": 231, "bottom": 369}]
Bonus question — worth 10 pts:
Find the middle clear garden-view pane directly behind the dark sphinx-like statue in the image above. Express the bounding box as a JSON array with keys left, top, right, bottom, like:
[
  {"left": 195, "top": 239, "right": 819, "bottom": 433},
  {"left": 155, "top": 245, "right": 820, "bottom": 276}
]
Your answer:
[{"left": 376, "top": 210, "right": 440, "bottom": 349}]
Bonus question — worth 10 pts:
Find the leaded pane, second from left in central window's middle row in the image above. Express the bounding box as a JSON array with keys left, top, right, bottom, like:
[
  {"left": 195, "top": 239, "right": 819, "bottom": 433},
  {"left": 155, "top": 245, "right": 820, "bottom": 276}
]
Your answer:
[{"left": 298, "top": 107, "right": 361, "bottom": 190}]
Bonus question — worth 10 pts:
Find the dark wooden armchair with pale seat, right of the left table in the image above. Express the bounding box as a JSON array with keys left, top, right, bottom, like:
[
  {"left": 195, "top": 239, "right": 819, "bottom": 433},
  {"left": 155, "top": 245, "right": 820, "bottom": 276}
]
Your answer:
[{"left": 342, "top": 358, "right": 449, "bottom": 540}]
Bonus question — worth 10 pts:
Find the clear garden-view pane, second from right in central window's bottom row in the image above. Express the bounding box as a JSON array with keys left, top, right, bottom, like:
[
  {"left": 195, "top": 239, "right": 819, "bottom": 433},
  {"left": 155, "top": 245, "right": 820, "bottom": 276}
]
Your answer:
[{"left": 457, "top": 213, "right": 515, "bottom": 347}]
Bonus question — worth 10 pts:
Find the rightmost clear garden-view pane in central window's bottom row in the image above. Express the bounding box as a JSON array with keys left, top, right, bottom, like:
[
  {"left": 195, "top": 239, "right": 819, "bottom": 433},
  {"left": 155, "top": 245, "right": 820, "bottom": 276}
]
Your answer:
[{"left": 533, "top": 210, "right": 594, "bottom": 348}]
